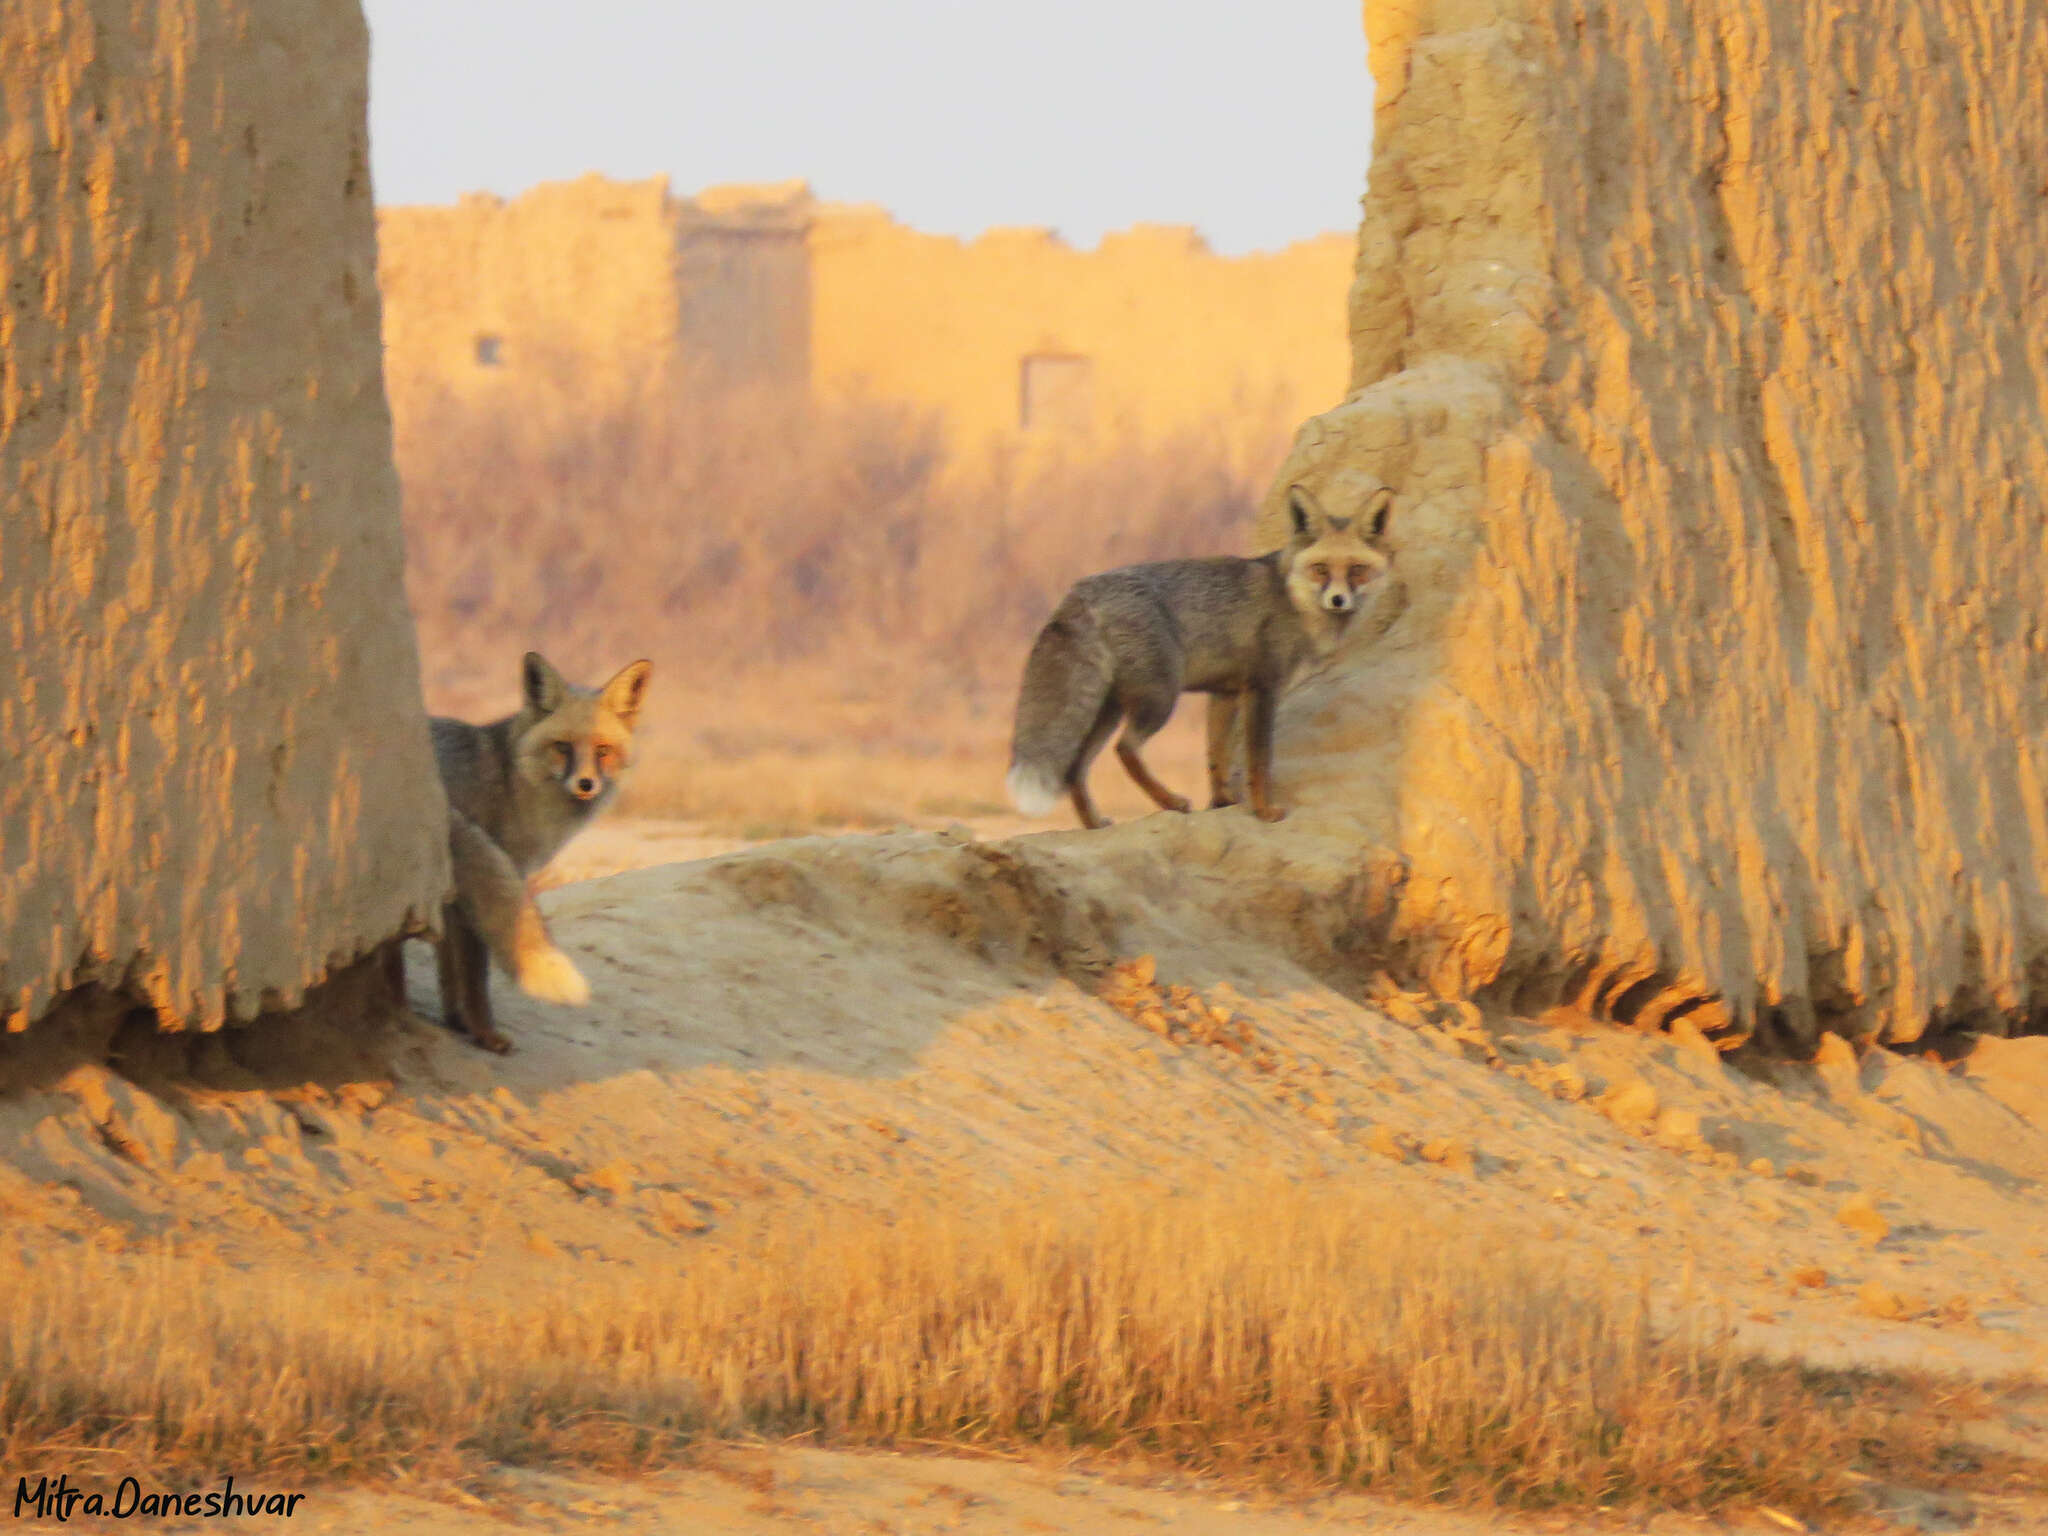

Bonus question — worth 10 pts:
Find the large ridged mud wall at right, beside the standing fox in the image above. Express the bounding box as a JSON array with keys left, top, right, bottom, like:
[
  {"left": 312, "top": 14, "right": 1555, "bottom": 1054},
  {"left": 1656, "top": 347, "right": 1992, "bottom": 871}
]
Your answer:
[{"left": 1264, "top": 0, "right": 2048, "bottom": 1038}]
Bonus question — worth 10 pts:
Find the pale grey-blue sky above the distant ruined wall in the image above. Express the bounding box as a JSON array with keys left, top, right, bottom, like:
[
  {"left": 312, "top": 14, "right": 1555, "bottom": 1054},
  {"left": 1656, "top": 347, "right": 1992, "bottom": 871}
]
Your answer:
[{"left": 365, "top": 0, "right": 1372, "bottom": 254}]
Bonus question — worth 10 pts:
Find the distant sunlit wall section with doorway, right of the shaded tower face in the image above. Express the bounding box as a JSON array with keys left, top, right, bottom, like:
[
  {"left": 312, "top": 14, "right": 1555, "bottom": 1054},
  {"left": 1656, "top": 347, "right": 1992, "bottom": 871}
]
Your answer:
[{"left": 811, "top": 207, "right": 1350, "bottom": 453}]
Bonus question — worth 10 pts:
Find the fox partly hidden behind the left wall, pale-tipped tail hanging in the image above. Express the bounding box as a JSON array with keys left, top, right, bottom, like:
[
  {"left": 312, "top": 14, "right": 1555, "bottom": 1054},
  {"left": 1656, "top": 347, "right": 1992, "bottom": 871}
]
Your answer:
[{"left": 397, "top": 651, "right": 653, "bottom": 1055}]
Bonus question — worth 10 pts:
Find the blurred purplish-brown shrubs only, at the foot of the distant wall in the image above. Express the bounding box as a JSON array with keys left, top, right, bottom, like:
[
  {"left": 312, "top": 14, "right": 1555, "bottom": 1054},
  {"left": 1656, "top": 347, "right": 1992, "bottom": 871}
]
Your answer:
[{"left": 395, "top": 382, "right": 1286, "bottom": 696}]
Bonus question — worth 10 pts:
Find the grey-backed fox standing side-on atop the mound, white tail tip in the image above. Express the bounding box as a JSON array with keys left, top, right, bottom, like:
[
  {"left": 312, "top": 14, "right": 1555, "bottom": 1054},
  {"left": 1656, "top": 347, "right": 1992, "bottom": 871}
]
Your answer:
[{"left": 1010, "top": 485, "right": 1393, "bottom": 827}]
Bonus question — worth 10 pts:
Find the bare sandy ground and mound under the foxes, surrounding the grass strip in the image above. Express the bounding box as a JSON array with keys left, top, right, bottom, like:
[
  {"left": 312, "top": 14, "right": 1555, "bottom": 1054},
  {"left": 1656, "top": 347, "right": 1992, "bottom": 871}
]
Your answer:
[{"left": 0, "top": 811, "right": 2048, "bottom": 1536}]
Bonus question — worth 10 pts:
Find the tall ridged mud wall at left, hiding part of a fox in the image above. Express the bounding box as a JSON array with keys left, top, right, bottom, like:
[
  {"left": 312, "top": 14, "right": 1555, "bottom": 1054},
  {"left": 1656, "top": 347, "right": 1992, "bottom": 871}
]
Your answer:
[{"left": 0, "top": 0, "right": 449, "bottom": 1028}]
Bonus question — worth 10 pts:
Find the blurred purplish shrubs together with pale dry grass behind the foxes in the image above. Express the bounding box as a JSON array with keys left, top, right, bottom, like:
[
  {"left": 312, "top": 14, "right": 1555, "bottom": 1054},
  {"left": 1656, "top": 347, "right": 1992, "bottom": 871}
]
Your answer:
[{"left": 397, "top": 395, "right": 1286, "bottom": 834}]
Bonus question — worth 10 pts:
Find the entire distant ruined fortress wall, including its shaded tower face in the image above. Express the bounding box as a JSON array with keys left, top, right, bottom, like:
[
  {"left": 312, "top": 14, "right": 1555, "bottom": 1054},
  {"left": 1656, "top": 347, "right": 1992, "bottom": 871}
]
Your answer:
[{"left": 379, "top": 176, "right": 1352, "bottom": 459}]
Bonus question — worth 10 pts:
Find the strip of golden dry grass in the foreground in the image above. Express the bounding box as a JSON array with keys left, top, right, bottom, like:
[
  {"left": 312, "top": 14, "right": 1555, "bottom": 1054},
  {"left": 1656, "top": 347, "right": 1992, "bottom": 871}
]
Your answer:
[{"left": 0, "top": 1186, "right": 1990, "bottom": 1513}]
